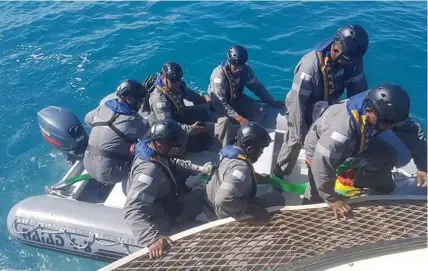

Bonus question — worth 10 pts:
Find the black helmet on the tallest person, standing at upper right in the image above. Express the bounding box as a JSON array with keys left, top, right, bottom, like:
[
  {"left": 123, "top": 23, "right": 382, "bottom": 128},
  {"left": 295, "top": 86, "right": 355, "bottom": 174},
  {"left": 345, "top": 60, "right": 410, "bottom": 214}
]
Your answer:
[{"left": 334, "top": 25, "right": 369, "bottom": 60}]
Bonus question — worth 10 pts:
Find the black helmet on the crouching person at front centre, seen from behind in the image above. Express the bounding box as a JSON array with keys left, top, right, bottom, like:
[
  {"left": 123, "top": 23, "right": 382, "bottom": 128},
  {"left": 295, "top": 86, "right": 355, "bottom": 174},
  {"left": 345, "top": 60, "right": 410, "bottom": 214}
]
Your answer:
[{"left": 236, "top": 122, "right": 272, "bottom": 150}]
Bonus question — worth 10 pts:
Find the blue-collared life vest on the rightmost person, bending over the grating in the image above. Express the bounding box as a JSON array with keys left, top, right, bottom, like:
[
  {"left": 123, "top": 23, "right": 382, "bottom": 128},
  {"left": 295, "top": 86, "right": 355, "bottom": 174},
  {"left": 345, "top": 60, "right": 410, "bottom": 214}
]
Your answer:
[{"left": 346, "top": 90, "right": 379, "bottom": 154}]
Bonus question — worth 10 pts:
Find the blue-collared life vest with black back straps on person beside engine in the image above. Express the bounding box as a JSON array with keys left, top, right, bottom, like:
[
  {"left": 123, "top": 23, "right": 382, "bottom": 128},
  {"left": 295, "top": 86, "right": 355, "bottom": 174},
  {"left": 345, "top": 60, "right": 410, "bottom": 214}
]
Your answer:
[{"left": 87, "top": 99, "right": 138, "bottom": 161}]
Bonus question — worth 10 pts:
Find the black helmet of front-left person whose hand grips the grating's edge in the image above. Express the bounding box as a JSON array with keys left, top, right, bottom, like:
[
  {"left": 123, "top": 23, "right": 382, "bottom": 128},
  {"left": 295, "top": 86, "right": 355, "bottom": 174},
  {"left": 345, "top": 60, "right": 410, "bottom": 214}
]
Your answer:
[{"left": 150, "top": 119, "right": 186, "bottom": 154}]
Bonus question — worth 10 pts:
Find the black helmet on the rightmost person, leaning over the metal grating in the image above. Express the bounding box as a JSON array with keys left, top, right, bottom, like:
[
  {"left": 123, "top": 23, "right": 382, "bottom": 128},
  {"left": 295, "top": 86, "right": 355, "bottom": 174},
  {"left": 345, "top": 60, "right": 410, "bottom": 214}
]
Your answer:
[{"left": 364, "top": 83, "right": 410, "bottom": 124}]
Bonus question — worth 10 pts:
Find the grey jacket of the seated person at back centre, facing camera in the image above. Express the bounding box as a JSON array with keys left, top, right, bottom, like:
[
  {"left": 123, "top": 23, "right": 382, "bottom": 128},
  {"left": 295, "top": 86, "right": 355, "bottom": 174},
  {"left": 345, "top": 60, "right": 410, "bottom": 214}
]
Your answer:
[{"left": 208, "top": 64, "right": 273, "bottom": 118}]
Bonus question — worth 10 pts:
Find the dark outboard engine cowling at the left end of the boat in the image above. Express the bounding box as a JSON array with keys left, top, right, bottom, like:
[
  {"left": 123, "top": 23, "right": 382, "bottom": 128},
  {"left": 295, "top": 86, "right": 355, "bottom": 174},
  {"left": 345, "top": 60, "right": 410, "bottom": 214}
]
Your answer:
[{"left": 37, "top": 106, "right": 89, "bottom": 163}]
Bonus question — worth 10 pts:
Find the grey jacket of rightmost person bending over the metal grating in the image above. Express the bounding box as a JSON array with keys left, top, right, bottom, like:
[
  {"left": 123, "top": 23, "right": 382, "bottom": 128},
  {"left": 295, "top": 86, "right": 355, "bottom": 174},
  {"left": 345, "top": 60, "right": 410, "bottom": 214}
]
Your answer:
[{"left": 304, "top": 101, "right": 427, "bottom": 202}]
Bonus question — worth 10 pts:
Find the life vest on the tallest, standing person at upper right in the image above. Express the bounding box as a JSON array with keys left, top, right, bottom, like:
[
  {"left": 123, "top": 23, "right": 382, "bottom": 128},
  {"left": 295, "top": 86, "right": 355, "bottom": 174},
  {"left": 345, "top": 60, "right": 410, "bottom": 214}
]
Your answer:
[{"left": 315, "top": 38, "right": 362, "bottom": 102}]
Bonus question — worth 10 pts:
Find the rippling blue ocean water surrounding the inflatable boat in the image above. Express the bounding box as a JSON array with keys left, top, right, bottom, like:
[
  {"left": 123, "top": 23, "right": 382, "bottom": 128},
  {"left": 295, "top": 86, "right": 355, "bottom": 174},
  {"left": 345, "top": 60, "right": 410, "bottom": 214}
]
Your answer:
[{"left": 0, "top": 1, "right": 427, "bottom": 270}]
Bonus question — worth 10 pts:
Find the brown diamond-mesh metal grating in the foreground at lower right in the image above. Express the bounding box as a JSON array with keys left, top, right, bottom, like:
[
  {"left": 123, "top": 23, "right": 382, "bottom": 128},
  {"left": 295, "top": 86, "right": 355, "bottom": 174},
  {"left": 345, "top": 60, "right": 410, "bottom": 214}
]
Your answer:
[{"left": 105, "top": 200, "right": 427, "bottom": 271}]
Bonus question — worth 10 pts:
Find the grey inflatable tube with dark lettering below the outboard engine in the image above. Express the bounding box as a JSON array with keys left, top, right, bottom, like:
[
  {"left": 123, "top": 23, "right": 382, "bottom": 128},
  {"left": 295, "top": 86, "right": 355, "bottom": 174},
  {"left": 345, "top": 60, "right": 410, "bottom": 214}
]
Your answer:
[{"left": 7, "top": 195, "right": 142, "bottom": 261}]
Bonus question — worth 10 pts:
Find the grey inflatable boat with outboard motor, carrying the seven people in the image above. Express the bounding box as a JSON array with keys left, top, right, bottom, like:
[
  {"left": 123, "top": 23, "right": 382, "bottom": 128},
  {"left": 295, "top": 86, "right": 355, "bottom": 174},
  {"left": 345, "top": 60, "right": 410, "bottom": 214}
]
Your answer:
[{"left": 7, "top": 94, "right": 424, "bottom": 262}]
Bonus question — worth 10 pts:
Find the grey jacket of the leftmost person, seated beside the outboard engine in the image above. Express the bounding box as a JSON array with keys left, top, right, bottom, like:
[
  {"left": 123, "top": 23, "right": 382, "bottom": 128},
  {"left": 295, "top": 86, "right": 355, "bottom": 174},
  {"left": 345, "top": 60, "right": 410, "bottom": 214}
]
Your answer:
[{"left": 85, "top": 105, "right": 149, "bottom": 164}]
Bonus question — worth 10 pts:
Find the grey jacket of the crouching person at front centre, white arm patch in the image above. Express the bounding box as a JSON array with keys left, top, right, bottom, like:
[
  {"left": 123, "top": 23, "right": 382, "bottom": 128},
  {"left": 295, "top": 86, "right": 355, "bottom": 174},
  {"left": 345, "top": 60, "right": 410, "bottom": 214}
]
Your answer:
[{"left": 206, "top": 158, "right": 257, "bottom": 219}]
